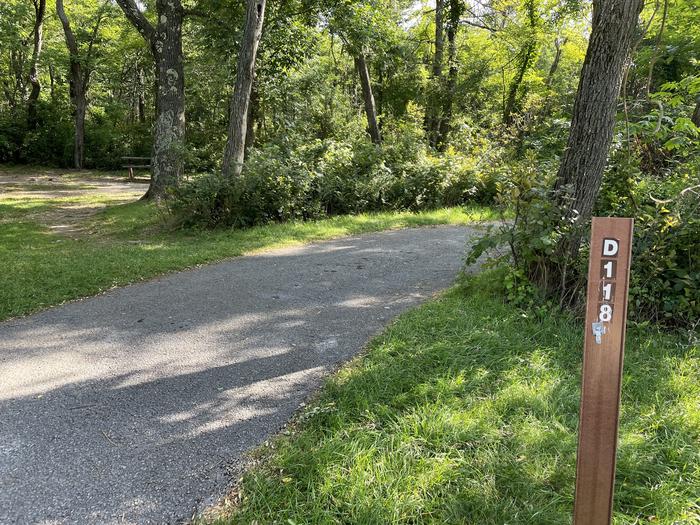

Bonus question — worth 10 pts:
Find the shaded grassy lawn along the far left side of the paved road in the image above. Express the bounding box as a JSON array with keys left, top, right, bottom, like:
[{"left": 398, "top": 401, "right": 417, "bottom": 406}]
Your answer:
[{"left": 0, "top": 171, "right": 494, "bottom": 319}]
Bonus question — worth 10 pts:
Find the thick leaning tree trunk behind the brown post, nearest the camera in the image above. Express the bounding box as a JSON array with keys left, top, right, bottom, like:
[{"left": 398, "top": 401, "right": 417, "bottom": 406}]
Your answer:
[{"left": 555, "top": 0, "right": 643, "bottom": 256}]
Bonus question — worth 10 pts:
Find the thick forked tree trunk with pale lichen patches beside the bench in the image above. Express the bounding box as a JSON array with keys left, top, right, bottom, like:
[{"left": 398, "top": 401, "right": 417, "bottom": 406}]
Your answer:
[{"left": 116, "top": 0, "right": 185, "bottom": 199}]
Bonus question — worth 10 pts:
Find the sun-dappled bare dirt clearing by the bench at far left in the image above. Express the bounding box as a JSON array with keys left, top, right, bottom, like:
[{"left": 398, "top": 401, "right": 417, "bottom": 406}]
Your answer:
[{"left": 0, "top": 166, "right": 148, "bottom": 236}]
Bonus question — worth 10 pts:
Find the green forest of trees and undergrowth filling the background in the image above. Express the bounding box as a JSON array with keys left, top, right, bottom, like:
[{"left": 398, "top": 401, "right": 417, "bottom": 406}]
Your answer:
[{"left": 0, "top": 0, "right": 700, "bottom": 328}]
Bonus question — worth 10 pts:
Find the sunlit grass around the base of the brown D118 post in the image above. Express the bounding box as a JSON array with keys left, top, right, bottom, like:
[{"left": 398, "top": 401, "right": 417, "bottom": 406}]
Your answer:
[{"left": 215, "top": 274, "right": 700, "bottom": 525}]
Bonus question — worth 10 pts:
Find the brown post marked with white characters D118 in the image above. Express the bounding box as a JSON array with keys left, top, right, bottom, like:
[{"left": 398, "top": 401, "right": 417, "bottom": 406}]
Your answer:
[{"left": 574, "top": 217, "right": 634, "bottom": 525}]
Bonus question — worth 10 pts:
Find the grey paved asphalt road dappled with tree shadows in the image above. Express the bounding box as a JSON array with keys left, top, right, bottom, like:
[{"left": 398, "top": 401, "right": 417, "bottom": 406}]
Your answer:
[{"left": 0, "top": 227, "right": 470, "bottom": 524}]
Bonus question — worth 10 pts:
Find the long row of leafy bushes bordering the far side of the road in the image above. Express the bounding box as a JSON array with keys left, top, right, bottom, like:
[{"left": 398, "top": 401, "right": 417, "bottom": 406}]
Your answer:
[{"left": 169, "top": 123, "right": 495, "bottom": 227}]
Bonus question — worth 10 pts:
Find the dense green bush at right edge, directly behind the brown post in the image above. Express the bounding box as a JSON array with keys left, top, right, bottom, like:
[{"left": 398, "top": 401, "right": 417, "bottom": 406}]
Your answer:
[{"left": 597, "top": 77, "right": 700, "bottom": 327}]
